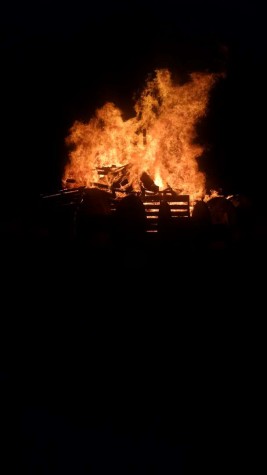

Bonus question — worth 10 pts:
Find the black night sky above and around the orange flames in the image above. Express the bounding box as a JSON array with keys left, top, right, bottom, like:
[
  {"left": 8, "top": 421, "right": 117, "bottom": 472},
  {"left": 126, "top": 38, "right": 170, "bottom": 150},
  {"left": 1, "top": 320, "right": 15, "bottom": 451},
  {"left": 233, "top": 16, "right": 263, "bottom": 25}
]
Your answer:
[{"left": 0, "top": 0, "right": 267, "bottom": 205}]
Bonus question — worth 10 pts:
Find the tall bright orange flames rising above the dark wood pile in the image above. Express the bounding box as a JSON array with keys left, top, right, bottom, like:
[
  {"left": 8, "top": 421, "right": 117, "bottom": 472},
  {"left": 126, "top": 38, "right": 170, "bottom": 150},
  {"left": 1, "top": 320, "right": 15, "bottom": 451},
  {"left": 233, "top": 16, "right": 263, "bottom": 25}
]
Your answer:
[{"left": 63, "top": 69, "right": 219, "bottom": 200}]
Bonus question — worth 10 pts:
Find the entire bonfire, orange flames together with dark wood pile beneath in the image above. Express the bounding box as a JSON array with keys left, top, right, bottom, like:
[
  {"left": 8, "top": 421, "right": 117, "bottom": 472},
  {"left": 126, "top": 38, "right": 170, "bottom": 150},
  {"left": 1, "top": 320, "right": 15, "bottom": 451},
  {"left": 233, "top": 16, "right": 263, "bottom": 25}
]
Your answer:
[{"left": 38, "top": 70, "right": 254, "bottom": 249}]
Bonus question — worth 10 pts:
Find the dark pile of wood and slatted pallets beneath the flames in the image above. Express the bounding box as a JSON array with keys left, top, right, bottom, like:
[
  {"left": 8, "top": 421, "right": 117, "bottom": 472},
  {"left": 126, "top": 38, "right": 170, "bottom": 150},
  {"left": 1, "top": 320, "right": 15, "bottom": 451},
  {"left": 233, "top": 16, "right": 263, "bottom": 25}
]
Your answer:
[{"left": 42, "top": 178, "right": 253, "bottom": 246}]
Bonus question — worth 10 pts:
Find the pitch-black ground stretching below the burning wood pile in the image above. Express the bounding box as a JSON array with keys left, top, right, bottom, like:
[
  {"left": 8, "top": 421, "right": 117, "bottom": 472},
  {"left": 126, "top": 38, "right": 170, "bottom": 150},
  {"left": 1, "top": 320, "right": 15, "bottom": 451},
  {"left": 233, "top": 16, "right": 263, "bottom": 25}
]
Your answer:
[{"left": 1, "top": 213, "right": 266, "bottom": 474}]
